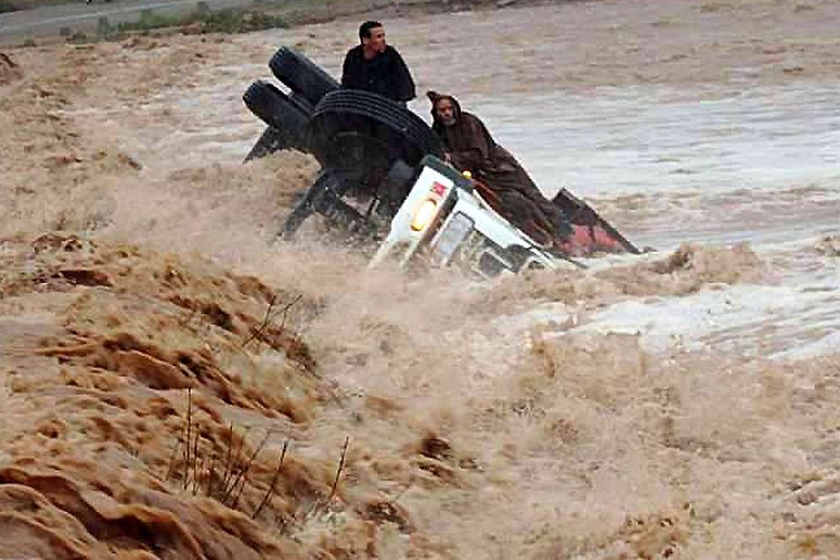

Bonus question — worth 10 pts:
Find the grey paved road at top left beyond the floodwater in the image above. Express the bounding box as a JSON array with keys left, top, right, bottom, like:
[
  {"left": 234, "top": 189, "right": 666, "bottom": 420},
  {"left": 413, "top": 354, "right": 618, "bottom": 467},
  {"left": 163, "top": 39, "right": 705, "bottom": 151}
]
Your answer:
[{"left": 0, "top": 0, "right": 254, "bottom": 45}]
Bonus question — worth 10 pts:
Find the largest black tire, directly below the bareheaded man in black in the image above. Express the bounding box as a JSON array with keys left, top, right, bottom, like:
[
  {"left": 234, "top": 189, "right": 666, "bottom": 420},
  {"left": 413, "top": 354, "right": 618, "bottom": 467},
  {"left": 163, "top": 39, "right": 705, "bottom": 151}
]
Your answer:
[{"left": 306, "top": 89, "right": 443, "bottom": 171}]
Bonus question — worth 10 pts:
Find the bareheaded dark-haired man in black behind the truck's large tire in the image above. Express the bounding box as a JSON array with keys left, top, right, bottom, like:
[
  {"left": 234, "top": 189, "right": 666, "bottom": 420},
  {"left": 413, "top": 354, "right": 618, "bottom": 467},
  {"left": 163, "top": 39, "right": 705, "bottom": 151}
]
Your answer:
[{"left": 341, "top": 21, "right": 416, "bottom": 104}]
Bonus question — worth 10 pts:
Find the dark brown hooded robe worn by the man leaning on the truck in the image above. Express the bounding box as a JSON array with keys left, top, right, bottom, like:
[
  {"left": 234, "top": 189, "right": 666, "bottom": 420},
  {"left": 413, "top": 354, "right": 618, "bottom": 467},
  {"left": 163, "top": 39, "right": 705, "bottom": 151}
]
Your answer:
[{"left": 427, "top": 91, "right": 571, "bottom": 241}]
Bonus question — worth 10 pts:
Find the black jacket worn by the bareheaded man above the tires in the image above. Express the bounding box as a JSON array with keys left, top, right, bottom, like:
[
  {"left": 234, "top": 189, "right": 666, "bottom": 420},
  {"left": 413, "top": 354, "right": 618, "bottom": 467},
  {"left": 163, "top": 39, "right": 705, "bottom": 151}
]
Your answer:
[{"left": 341, "top": 45, "right": 416, "bottom": 102}]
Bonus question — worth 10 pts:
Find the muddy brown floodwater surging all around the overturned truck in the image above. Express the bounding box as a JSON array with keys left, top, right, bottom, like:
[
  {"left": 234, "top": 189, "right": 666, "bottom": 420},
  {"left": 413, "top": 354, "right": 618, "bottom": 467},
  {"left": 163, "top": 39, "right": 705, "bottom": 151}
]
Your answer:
[{"left": 0, "top": 0, "right": 840, "bottom": 560}]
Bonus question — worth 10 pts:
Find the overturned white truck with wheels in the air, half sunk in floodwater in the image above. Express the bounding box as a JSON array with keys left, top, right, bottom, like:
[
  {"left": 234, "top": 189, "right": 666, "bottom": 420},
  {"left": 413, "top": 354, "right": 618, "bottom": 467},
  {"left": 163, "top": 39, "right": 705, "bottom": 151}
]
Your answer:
[{"left": 243, "top": 47, "right": 639, "bottom": 278}]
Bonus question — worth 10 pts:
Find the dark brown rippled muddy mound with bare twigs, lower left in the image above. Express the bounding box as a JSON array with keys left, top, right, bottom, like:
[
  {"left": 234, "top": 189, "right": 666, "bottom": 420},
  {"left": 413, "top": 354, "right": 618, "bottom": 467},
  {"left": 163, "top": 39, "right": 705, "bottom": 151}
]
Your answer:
[{"left": 0, "top": 234, "right": 452, "bottom": 558}]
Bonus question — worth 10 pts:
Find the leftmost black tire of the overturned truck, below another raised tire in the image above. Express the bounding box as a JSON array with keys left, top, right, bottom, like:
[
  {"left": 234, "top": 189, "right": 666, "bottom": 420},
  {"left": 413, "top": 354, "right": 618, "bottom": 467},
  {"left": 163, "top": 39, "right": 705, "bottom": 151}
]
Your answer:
[{"left": 242, "top": 80, "right": 308, "bottom": 151}]
